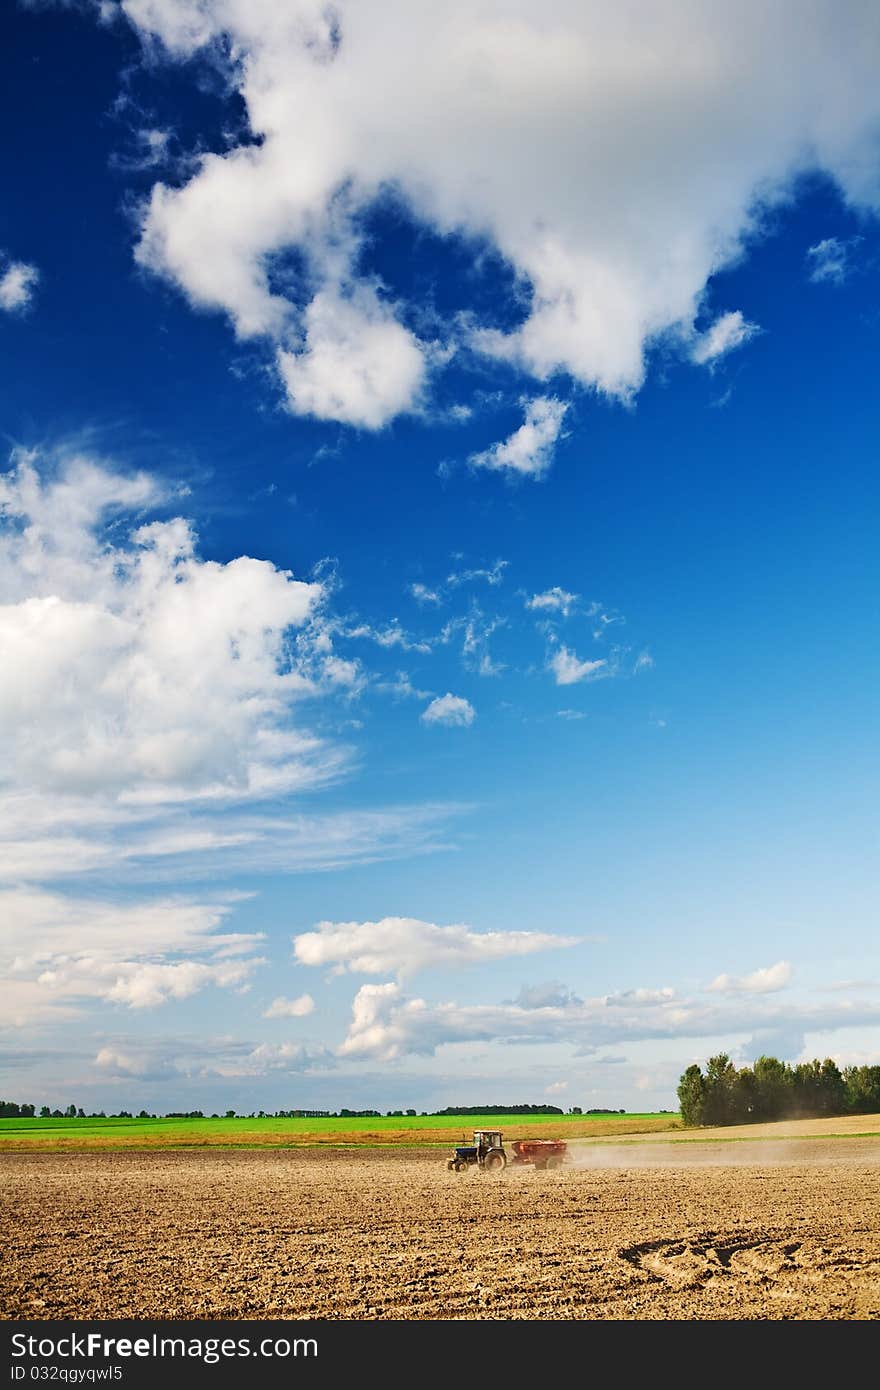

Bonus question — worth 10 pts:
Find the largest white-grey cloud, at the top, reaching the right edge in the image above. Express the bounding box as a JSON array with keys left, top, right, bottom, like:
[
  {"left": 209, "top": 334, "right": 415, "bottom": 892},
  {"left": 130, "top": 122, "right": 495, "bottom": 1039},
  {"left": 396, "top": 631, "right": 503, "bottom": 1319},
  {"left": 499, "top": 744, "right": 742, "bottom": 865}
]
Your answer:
[{"left": 113, "top": 0, "right": 880, "bottom": 425}]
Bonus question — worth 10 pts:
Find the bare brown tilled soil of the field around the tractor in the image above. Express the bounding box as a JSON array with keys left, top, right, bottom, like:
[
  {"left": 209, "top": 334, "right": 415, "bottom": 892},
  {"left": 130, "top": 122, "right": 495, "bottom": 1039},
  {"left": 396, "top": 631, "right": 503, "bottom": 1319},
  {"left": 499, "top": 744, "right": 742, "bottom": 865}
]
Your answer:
[{"left": 0, "top": 1137, "right": 880, "bottom": 1319}]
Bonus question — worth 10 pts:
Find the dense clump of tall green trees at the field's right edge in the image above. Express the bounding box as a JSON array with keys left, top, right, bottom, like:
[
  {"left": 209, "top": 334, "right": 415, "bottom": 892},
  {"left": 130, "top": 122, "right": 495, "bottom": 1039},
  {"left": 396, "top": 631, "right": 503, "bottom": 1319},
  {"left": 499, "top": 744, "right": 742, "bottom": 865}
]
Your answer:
[{"left": 678, "top": 1052, "right": 880, "bottom": 1126}]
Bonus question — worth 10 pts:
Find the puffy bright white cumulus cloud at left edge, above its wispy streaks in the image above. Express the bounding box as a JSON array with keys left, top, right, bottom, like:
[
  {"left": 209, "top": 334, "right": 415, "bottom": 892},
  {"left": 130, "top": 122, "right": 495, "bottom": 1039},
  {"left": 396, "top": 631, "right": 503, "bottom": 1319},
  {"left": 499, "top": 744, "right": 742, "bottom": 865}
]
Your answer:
[{"left": 0, "top": 455, "right": 329, "bottom": 801}]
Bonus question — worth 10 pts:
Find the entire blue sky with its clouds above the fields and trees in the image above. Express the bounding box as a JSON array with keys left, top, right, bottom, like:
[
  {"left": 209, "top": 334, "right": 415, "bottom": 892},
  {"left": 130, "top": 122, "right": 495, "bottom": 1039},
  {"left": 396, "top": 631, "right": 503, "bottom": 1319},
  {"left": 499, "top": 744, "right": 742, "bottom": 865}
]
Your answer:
[{"left": 0, "top": 0, "right": 880, "bottom": 1109}]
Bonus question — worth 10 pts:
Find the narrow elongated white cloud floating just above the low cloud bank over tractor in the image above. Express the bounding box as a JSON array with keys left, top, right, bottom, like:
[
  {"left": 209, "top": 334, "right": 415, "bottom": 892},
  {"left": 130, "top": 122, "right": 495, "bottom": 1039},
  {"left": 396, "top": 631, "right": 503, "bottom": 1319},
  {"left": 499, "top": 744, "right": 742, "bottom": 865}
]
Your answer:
[{"left": 293, "top": 917, "right": 578, "bottom": 977}]
